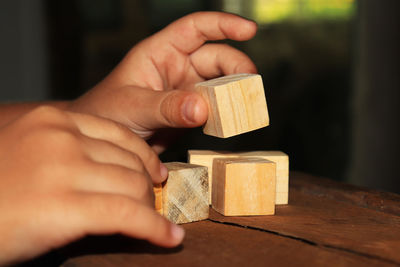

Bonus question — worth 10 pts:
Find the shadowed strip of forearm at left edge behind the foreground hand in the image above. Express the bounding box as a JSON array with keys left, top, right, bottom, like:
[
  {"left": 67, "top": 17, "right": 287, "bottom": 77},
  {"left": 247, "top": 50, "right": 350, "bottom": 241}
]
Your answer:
[{"left": 0, "top": 101, "right": 69, "bottom": 128}]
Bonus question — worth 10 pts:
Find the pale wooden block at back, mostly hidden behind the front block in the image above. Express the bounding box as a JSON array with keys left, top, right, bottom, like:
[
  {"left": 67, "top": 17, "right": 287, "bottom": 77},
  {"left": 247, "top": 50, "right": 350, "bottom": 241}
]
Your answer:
[{"left": 188, "top": 150, "right": 289, "bottom": 205}]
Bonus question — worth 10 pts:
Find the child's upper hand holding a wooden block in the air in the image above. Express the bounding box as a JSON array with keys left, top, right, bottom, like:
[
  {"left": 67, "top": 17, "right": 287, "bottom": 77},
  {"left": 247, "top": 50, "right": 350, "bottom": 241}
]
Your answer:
[{"left": 71, "top": 12, "right": 257, "bottom": 152}]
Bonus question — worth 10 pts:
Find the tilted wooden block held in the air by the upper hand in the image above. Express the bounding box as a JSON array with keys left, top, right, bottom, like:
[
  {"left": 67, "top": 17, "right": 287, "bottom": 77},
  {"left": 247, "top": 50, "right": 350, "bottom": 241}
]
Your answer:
[{"left": 195, "top": 73, "right": 269, "bottom": 138}]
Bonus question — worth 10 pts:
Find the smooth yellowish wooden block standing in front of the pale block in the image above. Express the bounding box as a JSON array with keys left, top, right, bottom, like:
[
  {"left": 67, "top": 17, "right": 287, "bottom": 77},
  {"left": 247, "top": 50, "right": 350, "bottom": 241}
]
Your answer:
[{"left": 212, "top": 158, "right": 276, "bottom": 216}]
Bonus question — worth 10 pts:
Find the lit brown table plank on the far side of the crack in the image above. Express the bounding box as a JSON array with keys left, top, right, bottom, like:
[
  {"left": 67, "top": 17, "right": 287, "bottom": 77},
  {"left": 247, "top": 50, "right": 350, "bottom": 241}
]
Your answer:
[{"left": 210, "top": 173, "right": 400, "bottom": 264}]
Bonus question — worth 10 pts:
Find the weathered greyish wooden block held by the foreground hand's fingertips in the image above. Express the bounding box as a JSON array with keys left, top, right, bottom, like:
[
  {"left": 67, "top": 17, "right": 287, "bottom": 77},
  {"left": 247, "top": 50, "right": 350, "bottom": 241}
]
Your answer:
[{"left": 162, "top": 162, "right": 209, "bottom": 223}]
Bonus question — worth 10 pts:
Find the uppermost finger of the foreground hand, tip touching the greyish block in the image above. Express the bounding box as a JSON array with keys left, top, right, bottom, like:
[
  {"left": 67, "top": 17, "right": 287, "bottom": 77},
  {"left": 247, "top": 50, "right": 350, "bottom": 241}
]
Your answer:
[{"left": 69, "top": 112, "right": 168, "bottom": 183}]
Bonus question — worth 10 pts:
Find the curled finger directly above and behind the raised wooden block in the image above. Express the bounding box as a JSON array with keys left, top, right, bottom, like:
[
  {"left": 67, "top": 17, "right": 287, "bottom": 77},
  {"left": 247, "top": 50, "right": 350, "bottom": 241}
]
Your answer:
[{"left": 190, "top": 44, "right": 257, "bottom": 79}]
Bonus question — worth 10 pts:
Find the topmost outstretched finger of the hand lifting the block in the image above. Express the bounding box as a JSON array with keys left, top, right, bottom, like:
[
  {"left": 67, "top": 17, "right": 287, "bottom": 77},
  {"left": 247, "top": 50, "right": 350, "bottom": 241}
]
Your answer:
[{"left": 152, "top": 12, "right": 257, "bottom": 54}]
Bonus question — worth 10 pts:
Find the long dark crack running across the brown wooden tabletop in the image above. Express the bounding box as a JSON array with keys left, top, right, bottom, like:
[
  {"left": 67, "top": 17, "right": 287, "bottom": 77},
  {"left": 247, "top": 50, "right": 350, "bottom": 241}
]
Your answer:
[{"left": 207, "top": 218, "right": 400, "bottom": 265}]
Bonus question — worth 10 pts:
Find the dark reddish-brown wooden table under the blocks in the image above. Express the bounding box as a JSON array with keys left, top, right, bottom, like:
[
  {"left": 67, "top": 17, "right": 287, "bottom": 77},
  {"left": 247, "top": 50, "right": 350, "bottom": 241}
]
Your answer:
[{"left": 24, "top": 173, "right": 400, "bottom": 267}]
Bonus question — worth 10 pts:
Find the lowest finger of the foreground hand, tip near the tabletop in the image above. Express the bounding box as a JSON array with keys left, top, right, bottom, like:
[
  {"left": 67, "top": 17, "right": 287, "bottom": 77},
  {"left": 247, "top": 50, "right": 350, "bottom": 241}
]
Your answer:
[{"left": 74, "top": 194, "right": 184, "bottom": 247}]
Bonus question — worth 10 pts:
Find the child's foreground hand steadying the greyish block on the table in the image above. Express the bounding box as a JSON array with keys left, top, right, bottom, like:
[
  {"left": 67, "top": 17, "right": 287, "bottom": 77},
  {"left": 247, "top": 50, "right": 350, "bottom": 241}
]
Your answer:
[{"left": 0, "top": 107, "right": 183, "bottom": 265}]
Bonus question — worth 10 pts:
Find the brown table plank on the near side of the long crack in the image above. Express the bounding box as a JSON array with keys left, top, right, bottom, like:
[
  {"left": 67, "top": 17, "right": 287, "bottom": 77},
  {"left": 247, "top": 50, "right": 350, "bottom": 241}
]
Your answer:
[{"left": 62, "top": 221, "right": 395, "bottom": 267}]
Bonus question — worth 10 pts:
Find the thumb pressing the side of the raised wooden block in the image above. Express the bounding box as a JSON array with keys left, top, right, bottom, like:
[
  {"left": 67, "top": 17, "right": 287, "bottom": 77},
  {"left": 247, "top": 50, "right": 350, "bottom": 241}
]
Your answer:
[{"left": 129, "top": 87, "right": 208, "bottom": 130}]
